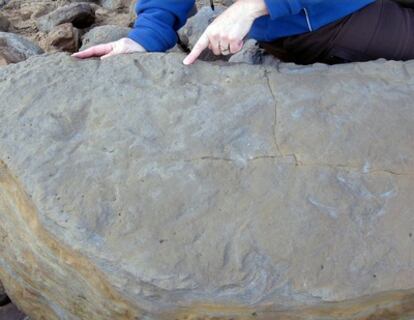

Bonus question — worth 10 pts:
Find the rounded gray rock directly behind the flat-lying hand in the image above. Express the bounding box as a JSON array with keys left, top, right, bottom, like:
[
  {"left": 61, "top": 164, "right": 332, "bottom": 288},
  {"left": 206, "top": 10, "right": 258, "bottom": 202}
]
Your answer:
[{"left": 80, "top": 25, "right": 131, "bottom": 50}]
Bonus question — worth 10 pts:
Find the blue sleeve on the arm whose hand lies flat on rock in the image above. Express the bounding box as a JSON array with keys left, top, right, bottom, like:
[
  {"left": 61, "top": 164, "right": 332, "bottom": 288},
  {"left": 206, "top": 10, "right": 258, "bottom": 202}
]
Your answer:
[{"left": 128, "top": 0, "right": 195, "bottom": 52}]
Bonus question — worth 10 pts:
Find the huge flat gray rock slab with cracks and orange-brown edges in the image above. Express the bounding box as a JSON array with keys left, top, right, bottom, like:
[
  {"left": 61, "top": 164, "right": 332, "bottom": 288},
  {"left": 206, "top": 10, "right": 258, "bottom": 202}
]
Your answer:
[{"left": 0, "top": 54, "right": 414, "bottom": 320}]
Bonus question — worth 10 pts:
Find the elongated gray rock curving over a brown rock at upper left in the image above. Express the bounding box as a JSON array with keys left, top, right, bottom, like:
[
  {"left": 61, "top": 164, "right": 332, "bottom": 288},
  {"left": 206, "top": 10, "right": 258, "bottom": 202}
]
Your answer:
[{"left": 36, "top": 2, "right": 95, "bottom": 32}]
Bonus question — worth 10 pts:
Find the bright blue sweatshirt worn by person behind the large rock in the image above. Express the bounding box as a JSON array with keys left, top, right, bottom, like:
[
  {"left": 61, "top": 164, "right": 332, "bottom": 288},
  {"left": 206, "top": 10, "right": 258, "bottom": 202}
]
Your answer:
[{"left": 128, "top": 0, "right": 375, "bottom": 52}]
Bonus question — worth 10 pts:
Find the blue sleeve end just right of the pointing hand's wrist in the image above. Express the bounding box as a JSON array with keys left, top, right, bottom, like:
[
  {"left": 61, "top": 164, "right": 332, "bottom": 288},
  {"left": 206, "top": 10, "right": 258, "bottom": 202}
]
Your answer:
[{"left": 264, "top": 0, "right": 318, "bottom": 20}]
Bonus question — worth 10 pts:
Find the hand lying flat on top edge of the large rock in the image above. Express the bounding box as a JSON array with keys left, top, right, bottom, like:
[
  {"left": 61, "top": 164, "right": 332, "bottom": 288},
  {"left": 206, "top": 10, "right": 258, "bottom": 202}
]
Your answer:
[{"left": 71, "top": 38, "right": 146, "bottom": 59}]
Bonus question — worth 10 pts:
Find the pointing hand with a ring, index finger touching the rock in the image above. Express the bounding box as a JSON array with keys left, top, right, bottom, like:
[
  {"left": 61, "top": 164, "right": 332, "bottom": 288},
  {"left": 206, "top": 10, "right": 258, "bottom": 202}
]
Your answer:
[{"left": 183, "top": 0, "right": 268, "bottom": 65}]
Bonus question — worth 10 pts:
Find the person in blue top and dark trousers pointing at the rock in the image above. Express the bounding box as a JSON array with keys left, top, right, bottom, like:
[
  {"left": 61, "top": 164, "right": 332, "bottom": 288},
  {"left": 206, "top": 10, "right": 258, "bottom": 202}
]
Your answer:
[{"left": 72, "top": 0, "right": 414, "bottom": 65}]
